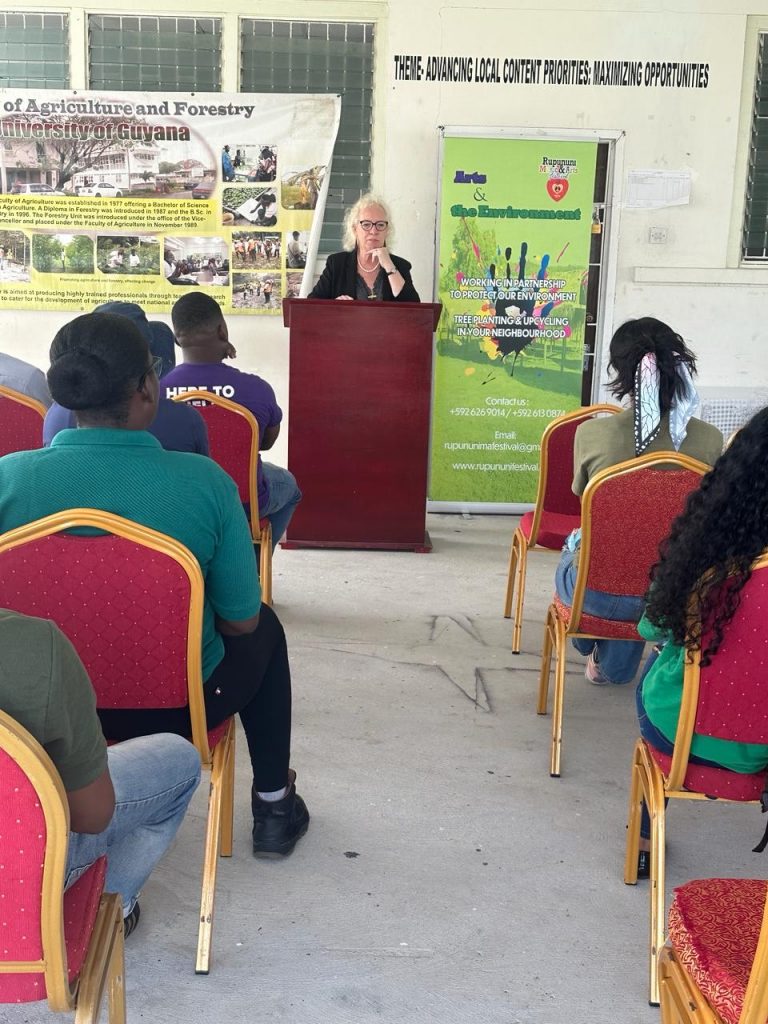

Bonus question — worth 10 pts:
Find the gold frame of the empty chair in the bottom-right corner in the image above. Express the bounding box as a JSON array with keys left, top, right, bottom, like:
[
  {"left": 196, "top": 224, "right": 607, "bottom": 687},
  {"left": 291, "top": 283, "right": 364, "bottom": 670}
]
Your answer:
[{"left": 658, "top": 880, "right": 768, "bottom": 1024}]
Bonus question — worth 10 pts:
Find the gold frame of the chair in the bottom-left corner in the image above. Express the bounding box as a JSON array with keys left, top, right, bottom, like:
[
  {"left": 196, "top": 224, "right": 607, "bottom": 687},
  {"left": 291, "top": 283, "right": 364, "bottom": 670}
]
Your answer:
[{"left": 0, "top": 711, "right": 126, "bottom": 1024}]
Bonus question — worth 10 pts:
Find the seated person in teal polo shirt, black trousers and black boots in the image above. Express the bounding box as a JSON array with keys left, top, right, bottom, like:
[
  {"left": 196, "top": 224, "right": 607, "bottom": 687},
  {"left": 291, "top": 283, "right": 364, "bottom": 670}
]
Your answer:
[{"left": 0, "top": 313, "right": 309, "bottom": 856}]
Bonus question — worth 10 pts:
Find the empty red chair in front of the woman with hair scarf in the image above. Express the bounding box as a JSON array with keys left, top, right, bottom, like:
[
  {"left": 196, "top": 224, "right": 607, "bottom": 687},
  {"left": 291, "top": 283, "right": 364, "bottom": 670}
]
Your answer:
[{"left": 504, "top": 404, "right": 622, "bottom": 654}]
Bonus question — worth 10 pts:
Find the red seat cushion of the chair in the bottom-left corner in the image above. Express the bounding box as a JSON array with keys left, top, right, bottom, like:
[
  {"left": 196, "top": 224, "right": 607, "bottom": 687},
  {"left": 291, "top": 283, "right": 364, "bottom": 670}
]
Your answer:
[{"left": 0, "top": 857, "right": 106, "bottom": 1002}]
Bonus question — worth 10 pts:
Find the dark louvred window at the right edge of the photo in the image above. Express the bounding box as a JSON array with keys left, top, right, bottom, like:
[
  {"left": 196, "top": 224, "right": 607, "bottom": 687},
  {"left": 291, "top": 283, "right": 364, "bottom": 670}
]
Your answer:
[{"left": 741, "top": 32, "right": 768, "bottom": 262}]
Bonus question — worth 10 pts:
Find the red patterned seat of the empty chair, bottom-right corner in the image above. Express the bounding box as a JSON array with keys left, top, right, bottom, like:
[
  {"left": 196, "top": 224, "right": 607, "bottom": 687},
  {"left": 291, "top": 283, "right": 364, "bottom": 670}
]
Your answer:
[{"left": 670, "top": 879, "right": 766, "bottom": 1024}]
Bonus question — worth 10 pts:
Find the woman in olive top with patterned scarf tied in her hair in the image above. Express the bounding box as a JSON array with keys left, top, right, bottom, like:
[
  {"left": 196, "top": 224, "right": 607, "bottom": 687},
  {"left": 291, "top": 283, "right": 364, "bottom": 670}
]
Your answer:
[{"left": 555, "top": 316, "right": 723, "bottom": 685}]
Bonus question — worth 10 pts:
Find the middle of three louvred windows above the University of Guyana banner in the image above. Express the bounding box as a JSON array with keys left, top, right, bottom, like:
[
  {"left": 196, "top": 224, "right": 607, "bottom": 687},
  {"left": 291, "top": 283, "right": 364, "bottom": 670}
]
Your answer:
[{"left": 88, "top": 14, "right": 221, "bottom": 92}]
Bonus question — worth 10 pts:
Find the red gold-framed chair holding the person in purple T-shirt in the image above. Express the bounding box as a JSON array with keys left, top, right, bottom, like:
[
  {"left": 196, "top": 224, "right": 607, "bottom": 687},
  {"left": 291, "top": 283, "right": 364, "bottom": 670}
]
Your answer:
[{"left": 173, "top": 390, "right": 280, "bottom": 604}]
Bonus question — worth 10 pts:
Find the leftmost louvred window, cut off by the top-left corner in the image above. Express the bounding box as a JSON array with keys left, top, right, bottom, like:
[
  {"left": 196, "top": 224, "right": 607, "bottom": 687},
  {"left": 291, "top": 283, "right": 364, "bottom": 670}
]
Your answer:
[{"left": 0, "top": 11, "right": 70, "bottom": 89}]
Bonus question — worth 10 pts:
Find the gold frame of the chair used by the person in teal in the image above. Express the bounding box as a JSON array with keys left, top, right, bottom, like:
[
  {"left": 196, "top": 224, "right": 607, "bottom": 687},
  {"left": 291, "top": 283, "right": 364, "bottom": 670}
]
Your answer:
[{"left": 0, "top": 508, "right": 236, "bottom": 974}]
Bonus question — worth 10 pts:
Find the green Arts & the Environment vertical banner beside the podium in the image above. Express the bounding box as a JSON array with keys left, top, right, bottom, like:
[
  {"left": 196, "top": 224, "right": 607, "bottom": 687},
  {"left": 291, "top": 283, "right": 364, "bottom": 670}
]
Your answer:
[{"left": 429, "top": 130, "right": 597, "bottom": 504}]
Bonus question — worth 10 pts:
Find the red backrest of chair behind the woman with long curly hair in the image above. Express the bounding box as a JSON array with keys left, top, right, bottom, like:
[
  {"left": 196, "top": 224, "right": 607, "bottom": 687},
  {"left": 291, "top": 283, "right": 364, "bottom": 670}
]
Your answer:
[{"left": 693, "top": 565, "right": 768, "bottom": 743}]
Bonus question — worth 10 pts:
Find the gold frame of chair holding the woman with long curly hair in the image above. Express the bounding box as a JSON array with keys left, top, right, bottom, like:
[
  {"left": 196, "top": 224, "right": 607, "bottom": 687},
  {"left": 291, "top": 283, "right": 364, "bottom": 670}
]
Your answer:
[{"left": 624, "top": 554, "right": 768, "bottom": 1007}]
